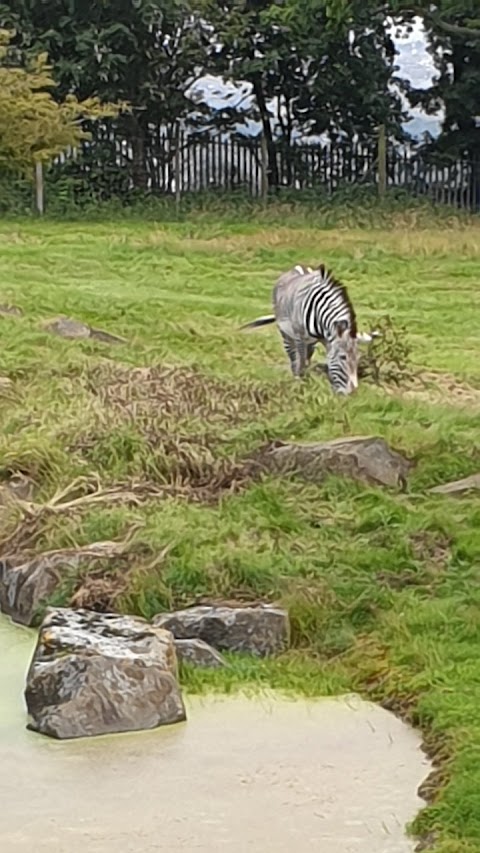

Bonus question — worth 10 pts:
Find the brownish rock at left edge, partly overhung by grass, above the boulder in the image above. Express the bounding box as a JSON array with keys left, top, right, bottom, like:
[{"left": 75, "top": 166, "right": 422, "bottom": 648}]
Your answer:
[{"left": 0, "top": 542, "right": 125, "bottom": 625}]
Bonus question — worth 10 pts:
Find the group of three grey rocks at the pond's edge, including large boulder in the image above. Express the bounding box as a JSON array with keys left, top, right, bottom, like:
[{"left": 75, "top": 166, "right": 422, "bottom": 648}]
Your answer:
[{"left": 25, "top": 605, "right": 289, "bottom": 738}]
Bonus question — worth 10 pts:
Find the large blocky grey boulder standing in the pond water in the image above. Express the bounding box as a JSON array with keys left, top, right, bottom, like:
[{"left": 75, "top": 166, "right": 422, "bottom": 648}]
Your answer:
[{"left": 25, "top": 608, "right": 186, "bottom": 739}]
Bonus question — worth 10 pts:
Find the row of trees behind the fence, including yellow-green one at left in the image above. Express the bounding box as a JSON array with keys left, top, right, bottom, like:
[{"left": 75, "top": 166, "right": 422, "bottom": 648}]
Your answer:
[{"left": 0, "top": 0, "right": 480, "bottom": 193}]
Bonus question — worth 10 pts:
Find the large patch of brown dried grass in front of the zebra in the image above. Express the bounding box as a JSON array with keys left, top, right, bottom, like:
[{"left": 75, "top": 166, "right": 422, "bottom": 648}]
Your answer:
[{"left": 64, "top": 364, "right": 273, "bottom": 503}]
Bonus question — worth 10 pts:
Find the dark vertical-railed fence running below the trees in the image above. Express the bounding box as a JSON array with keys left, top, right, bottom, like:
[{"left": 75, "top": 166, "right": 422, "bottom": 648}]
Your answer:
[{"left": 23, "top": 126, "right": 480, "bottom": 213}]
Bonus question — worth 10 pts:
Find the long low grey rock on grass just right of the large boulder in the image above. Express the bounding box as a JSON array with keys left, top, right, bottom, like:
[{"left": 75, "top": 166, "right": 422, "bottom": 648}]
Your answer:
[{"left": 153, "top": 604, "right": 290, "bottom": 657}]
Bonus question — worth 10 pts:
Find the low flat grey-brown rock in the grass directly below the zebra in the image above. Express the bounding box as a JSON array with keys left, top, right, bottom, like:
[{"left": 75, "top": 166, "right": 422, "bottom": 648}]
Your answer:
[{"left": 259, "top": 436, "right": 412, "bottom": 488}]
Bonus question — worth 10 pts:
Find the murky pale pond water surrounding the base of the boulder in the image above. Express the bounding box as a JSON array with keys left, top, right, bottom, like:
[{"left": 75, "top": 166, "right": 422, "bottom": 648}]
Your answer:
[{"left": 0, "top": 616, "right": 430, "bottom": 853}]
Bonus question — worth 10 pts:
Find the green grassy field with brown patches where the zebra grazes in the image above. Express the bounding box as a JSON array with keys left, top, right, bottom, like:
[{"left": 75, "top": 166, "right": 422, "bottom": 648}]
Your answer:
[{"left": 0, "top": 208, "right": 480, "bottom": 853}]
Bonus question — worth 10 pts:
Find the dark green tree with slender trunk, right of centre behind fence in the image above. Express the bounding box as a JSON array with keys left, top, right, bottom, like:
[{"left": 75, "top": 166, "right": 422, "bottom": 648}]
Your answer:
[{"left": 198, "top": 0, "right": 401, "bottom": 185}]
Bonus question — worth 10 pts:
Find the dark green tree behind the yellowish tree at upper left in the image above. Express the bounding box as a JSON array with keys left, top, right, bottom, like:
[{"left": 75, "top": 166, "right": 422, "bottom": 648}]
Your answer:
[{"left": 0, "top": 0, "right": 210, "bottom": 187}]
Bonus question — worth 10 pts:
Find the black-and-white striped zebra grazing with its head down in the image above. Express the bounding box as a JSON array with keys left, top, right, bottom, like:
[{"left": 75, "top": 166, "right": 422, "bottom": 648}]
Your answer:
[{"left": 241, "top": 264, "right": 375, "bottom": 394}]
